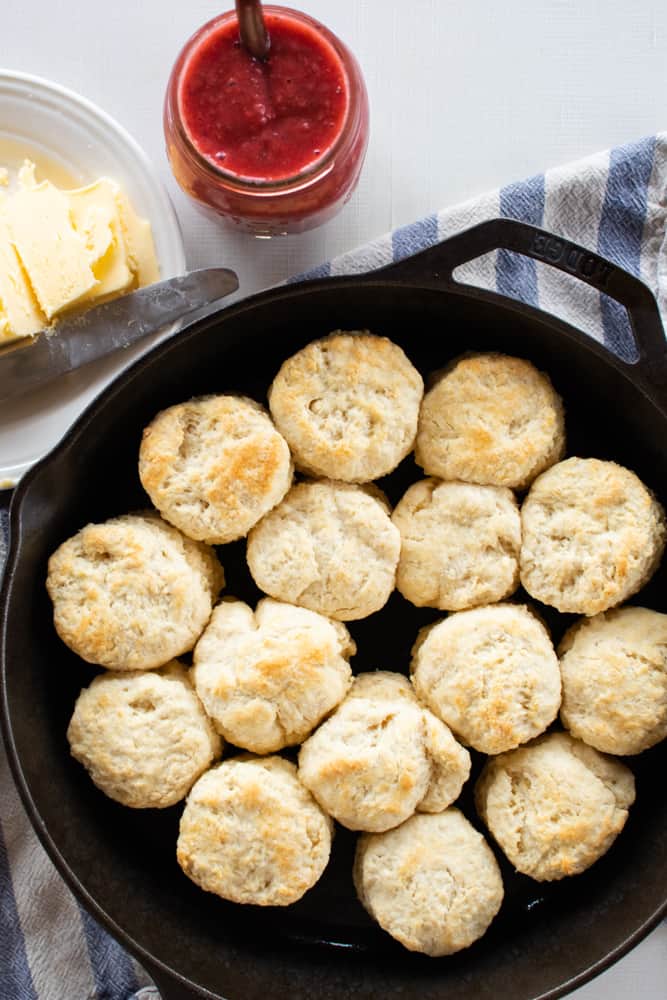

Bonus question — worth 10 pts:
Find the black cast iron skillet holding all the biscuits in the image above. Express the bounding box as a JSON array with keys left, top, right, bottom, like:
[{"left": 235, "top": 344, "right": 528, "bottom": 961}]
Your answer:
[{"left": 1, "top": 220, "right": 667, "bottom": 1000}]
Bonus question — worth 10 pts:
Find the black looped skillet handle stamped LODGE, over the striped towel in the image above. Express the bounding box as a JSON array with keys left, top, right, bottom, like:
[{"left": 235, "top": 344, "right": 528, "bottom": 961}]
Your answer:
[{"left": 382, "top": 219, "right": 667, "bottom": 389}]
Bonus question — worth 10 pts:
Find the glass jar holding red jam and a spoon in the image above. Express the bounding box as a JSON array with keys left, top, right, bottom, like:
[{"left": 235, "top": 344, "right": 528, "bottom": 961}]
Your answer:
[{"left": 164, "top": 4, "right": 368, "bottom": 236}]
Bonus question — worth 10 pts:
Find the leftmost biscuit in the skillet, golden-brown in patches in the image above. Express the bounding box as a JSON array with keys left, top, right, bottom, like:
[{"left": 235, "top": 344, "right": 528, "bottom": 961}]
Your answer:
[{"left": 46, "top": 512, "right": 225, "bottom": 670}]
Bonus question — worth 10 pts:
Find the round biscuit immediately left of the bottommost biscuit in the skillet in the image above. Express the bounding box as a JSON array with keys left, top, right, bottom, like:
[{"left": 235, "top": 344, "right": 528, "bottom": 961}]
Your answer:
[{"left": 176, "top": 756, "right": 333, "bottom": 906}]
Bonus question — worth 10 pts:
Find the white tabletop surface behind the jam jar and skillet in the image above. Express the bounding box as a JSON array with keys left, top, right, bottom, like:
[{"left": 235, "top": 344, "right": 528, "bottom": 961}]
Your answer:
[{"left": 5, "top": 0, "right": 667, "bottom": 1000}]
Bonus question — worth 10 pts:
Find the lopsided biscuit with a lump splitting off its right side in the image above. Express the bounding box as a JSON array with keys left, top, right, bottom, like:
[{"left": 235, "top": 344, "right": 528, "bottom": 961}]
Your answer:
[{"left": 299, "top": 671, "right": 470, "bottom": 832}]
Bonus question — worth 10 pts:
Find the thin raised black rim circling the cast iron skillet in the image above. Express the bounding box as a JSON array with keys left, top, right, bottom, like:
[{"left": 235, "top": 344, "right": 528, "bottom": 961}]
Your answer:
[{"left": 0, "top": 272, "right": 667, "bottom": 1000}]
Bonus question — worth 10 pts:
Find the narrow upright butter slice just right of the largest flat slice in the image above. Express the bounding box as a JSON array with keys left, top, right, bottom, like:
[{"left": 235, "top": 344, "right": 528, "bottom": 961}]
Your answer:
[{"left": 66, "top": 177, "right": 134, "bottom": 300}]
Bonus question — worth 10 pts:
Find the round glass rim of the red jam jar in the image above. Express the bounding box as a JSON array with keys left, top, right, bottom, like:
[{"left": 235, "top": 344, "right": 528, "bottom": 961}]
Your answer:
[{"left": 169, "top": 4, "right": 354, "bottom": 197}]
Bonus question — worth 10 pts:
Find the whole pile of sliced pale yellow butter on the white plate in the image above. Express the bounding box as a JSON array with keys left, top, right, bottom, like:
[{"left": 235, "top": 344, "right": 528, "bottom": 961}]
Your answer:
[{"left": 0, "top": 161, "right": 160, "bottom": 344}]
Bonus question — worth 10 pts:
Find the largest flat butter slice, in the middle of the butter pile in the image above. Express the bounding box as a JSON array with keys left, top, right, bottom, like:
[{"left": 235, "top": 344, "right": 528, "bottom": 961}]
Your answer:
[{"left": 5, "top": 181, "right": 97, "bottom": 320}]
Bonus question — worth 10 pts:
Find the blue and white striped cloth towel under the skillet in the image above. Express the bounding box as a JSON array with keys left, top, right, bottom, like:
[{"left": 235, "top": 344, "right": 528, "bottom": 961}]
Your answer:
[{"left": 0, "top": 133, "right": 667, "bottom": 1000}]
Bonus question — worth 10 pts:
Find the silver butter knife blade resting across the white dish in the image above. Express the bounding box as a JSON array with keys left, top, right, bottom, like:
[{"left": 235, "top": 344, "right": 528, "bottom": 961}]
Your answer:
[{"left": 0, "top": 267, "right": 239, "bottom": 402}]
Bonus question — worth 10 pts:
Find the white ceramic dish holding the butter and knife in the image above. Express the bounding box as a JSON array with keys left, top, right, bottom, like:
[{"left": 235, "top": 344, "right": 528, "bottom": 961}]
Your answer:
[{"left": 0, "top": 70, "right": 185, "bottom": 488}]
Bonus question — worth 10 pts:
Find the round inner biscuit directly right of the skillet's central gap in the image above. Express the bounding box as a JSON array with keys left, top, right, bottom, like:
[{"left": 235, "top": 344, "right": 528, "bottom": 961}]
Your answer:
[{"left": 411, "top": 604, "right": 561, "bottom": 754}]
